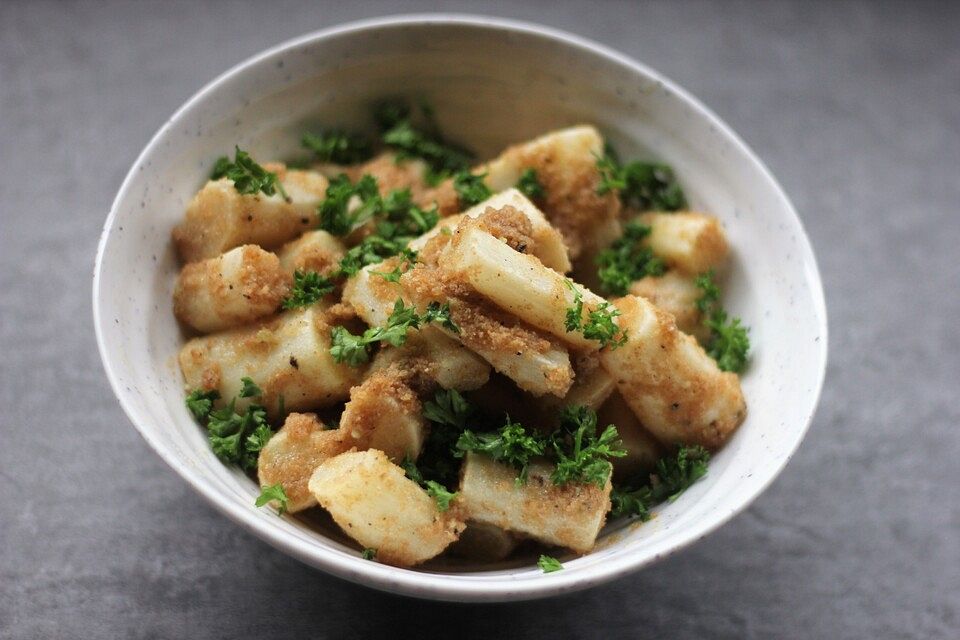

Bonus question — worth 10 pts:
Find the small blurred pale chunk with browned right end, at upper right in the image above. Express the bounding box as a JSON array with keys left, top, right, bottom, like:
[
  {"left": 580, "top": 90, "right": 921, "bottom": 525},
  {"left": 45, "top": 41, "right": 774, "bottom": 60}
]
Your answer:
[{"left": 637, "top": 211, "right": 729, "bottom": 277}]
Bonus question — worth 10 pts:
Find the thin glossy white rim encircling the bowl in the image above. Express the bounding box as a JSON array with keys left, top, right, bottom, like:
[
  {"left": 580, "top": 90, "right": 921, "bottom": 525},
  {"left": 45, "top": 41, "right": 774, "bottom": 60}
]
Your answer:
[{"left": 92, "top": 12, "right": 829, "bottom": 602}]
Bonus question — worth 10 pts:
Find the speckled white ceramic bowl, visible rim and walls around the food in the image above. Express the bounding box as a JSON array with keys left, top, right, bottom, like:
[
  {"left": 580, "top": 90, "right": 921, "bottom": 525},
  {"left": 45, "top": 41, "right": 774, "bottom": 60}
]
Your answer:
[{"left": 93, "top": 15, "right": 827, "bottom": 601}]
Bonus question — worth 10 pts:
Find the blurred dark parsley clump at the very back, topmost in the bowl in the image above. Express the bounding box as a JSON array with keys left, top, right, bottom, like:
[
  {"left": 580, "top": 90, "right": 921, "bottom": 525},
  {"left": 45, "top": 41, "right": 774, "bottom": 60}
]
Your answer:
[{"left": 374, "top": 101, "right": 472, "bottom": 184}]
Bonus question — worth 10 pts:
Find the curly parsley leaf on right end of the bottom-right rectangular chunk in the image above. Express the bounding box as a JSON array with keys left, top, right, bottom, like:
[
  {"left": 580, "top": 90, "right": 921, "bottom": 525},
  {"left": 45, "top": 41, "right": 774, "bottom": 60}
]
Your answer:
[{"left": 550, "top": 406, "right": 627, "bottom": 488}]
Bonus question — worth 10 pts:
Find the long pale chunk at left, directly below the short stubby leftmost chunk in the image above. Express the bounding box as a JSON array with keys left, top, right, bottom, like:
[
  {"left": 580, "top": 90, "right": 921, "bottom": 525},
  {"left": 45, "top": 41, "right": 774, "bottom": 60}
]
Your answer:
[{"left": 180, "top": 304, "right": 363, "bottom": 415}]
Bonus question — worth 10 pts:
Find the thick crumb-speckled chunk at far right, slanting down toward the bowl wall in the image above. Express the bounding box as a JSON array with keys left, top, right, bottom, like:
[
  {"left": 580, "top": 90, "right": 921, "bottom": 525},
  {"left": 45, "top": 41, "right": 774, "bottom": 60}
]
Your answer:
[{"left": 600, "top": 296, "right": 747, "bottom": 449}]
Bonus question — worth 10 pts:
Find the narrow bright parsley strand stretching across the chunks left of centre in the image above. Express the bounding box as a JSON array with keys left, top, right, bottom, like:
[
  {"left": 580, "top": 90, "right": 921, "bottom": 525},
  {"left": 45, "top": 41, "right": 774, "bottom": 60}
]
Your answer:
[{"left": 330, "top": 298, "right": 459, "bottom": 367}]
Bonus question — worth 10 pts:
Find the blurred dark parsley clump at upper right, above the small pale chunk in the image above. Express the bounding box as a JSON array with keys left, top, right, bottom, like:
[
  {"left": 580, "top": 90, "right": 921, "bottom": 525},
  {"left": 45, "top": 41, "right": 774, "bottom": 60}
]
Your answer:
[{"left": 597, "top": 148, "right": 687, "bottom": 211}]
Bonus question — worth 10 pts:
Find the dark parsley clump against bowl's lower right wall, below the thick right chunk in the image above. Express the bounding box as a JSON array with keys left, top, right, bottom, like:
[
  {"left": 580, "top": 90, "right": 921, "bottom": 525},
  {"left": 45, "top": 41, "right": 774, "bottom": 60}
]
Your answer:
[{"left": 610, "top": 446, "right": 710, "bottom": 520}]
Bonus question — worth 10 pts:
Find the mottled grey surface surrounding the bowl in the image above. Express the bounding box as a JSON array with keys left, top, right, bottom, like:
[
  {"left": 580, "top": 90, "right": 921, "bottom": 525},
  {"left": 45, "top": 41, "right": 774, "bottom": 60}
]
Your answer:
[{"left": 0, "top": 0, "right": 960, "bottom": 638}]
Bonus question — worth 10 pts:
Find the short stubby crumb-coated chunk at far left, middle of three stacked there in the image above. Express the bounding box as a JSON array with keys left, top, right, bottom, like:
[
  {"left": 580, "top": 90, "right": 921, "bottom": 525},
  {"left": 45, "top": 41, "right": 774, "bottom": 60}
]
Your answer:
[{"left": 173, "top": 244, "right": 290, "bottom": 333}]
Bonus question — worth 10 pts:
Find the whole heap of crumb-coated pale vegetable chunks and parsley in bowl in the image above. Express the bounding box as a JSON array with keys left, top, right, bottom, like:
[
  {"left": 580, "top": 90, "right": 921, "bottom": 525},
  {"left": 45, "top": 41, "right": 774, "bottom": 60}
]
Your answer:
[{"left": 173, "top": 101, "right": 749, "bottom": 571}]
